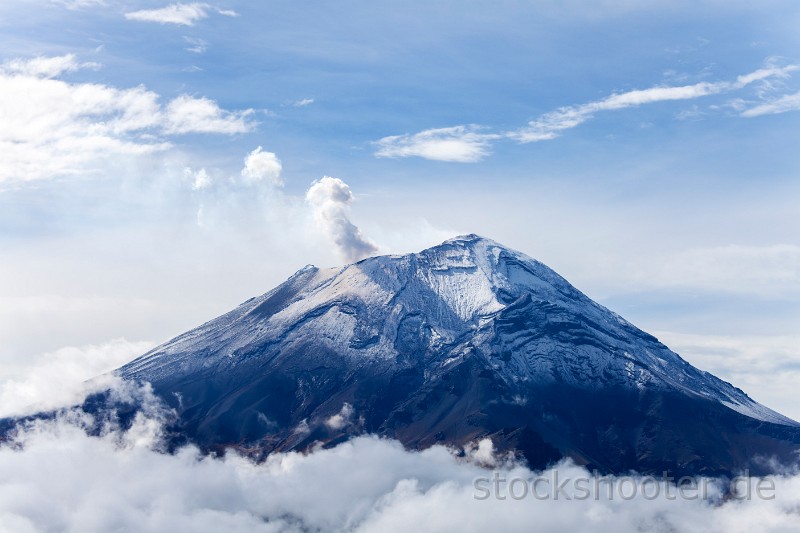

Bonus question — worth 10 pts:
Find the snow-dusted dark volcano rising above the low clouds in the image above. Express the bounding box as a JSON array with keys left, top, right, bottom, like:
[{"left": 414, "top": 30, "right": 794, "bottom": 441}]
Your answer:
[{"left": 119, "top": 235, "right": 800, "bottom": 474}]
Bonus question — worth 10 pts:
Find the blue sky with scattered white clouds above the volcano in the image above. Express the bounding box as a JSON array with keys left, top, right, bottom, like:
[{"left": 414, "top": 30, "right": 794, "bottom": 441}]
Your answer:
[{"left": 0, "top": 0, "right": 800, "bottom": 418}]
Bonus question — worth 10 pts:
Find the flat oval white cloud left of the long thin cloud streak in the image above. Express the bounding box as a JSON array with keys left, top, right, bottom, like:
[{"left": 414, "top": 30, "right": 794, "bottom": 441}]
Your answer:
[{"left": 375, "top": 125, "right": 499, "bottom": 163}]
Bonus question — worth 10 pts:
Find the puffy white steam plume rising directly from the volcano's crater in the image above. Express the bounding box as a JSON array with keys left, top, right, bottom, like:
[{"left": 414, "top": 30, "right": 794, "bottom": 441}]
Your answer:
[{"left": 306, "top": 176, "right": 378, "bottom": 262}]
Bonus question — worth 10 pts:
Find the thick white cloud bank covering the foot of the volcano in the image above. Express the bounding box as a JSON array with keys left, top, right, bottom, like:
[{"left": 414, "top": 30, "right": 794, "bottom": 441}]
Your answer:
[{"left": 0, "top": 406, "right": 800, "bottom": 533}]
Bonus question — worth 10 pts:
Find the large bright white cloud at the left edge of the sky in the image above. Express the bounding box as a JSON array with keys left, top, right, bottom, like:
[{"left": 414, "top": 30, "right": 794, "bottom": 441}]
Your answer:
[{"left": 0, "top": 55, "right": 254, "bottom": 182}]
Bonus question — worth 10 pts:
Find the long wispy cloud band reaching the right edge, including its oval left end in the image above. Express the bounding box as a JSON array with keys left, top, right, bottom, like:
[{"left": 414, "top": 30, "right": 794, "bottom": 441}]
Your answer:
[{"left": 373, "top": 65, "right": 800, "bottom": 163}]
